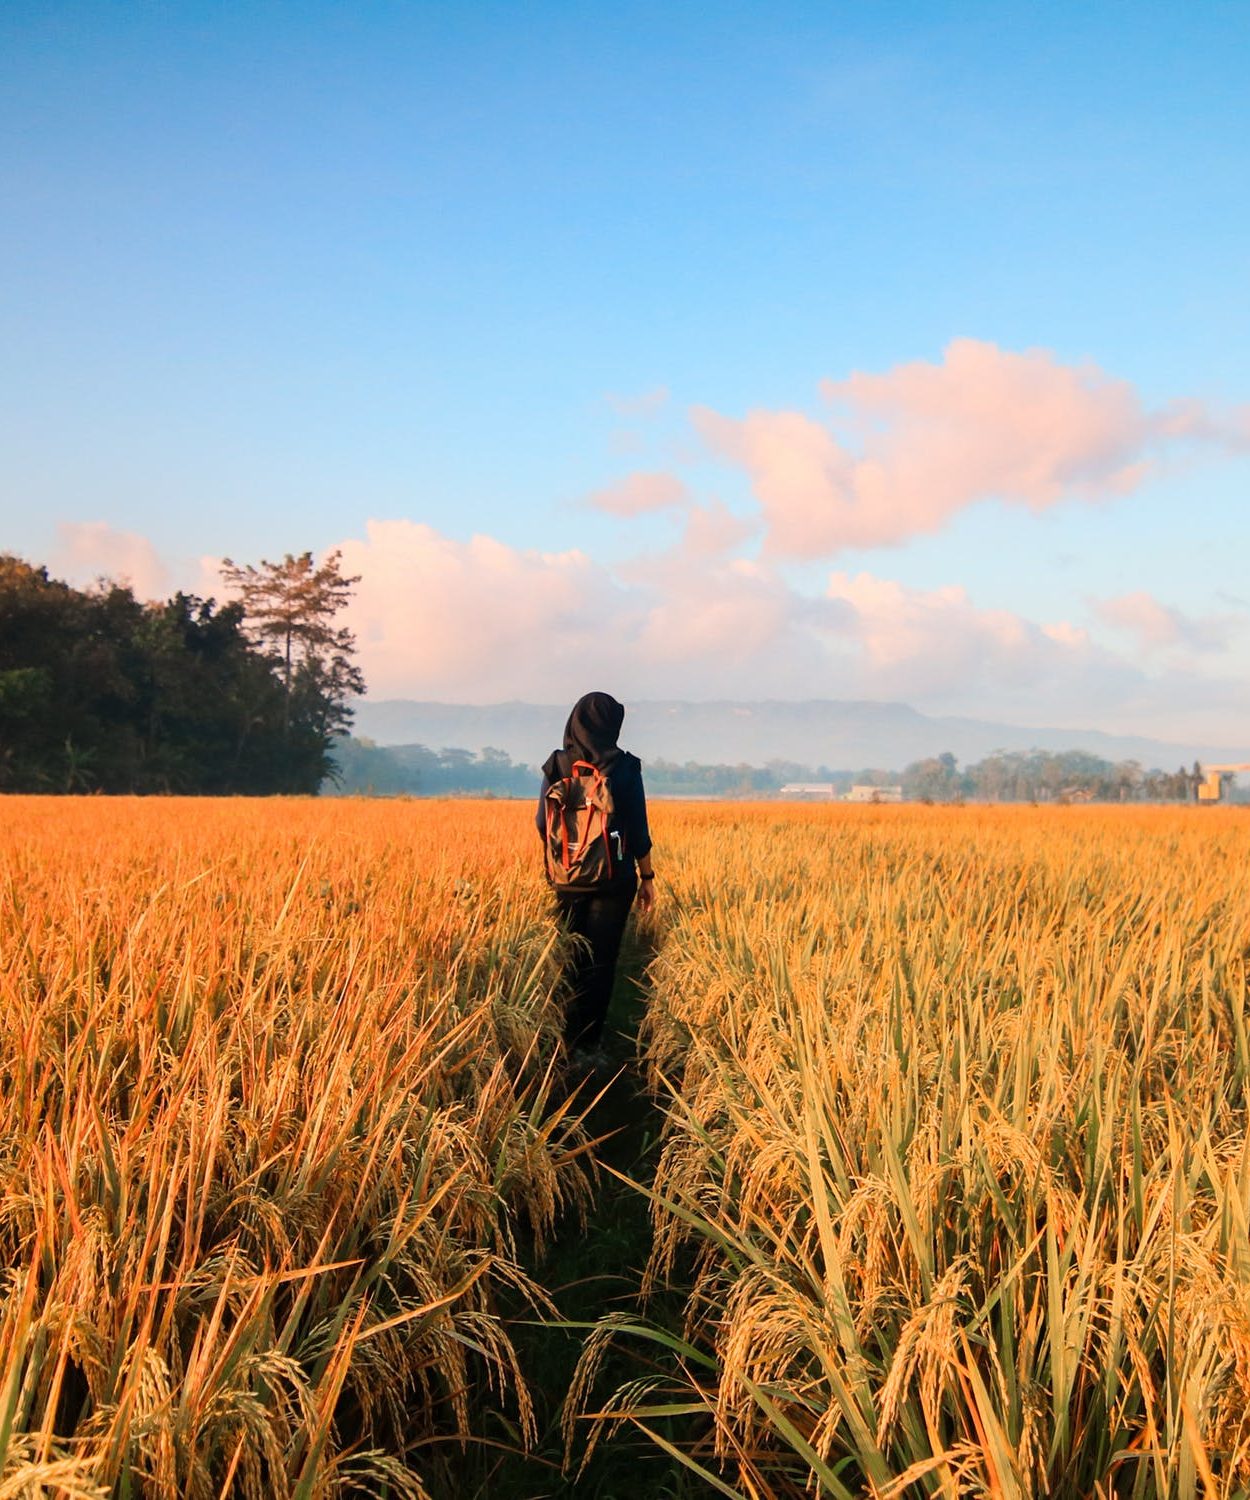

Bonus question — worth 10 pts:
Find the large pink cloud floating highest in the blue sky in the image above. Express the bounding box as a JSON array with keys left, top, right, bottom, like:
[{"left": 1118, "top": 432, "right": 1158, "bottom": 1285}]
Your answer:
[{"left": 690, "top": 339, "right": 1200, "bottom": 558}]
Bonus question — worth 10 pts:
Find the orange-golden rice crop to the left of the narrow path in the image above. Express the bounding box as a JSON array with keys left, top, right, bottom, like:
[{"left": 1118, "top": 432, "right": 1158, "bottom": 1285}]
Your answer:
[{"left": 0, "top": 798, "right": 590, "bottom": 1500}]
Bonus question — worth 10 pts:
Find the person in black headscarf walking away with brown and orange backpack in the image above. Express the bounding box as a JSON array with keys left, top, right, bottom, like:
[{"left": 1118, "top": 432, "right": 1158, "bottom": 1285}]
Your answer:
[{"left": 537, "top": 693, "right": 656, "bottom": 1061}]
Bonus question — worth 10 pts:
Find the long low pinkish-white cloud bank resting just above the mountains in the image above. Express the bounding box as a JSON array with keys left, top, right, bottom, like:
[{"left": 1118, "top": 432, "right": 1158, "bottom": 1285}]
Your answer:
[{"left": 39, "top": 506, "right": 1250, "bottom": 743}]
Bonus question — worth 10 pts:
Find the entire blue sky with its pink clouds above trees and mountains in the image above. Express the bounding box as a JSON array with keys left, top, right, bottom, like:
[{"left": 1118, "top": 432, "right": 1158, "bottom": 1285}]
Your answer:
[{"left": 0, "top": 0, "right": 1250, "bottom": 744}]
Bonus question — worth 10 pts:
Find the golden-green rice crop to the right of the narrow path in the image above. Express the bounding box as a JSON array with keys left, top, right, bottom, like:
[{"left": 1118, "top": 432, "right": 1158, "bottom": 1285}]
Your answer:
[{"left": 582, "top": 807, "right": 1250, "bottom": 1497}]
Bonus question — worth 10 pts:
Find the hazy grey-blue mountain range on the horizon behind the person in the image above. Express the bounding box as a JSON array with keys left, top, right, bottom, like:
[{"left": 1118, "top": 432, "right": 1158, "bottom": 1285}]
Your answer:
[{"left": 353, "top": 699, "right": 1250, "bottom": 771}]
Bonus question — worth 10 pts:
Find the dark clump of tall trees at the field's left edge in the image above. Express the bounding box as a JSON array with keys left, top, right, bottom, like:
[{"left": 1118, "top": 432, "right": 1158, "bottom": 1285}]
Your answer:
[{"left": 0, "top": 552, "right": 365, "bottom": 795}]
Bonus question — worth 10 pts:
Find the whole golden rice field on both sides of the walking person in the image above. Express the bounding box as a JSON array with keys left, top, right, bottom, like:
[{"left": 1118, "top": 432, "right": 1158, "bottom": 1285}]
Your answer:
[{"left": 0, "top": 798, "right": 1250, "bottom": 1500}]
